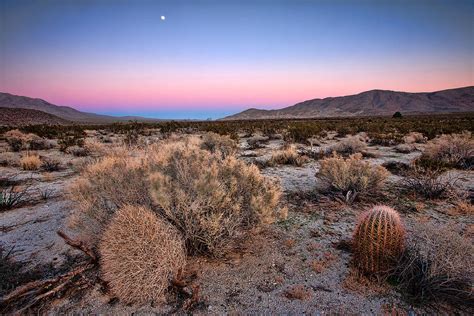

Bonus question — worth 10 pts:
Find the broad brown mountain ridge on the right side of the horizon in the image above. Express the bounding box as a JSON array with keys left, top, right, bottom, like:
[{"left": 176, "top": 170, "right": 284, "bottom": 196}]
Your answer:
[{"left": 223, "top": 86, "right": 474, "bottom": 120}]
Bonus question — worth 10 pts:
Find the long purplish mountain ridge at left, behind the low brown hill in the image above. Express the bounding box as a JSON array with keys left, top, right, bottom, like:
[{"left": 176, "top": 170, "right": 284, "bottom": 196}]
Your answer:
[{"left": 0, "top": 92, "right": 163, "bottom": 124}]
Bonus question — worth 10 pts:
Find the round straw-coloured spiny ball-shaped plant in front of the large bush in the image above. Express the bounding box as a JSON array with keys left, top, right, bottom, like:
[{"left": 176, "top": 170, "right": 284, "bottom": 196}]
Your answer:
[{"left": 99, "top": 206, "right": 186, "bottom": 304}]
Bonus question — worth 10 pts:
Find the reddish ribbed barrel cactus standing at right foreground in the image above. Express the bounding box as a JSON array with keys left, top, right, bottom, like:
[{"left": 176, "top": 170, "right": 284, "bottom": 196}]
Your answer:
[{"left": 353, "top": 205, "right": 405, "bottom": 274}]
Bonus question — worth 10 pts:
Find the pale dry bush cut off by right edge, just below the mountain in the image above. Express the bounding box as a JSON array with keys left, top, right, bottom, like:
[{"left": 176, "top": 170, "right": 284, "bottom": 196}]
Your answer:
[{"left": 422, "top": 132, "right": 474, "bottom": 169}]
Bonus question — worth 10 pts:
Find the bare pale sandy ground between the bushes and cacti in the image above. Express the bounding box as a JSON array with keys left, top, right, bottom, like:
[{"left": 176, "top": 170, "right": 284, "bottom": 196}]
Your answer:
[{"left": 0, "top": 135, "right": 474, "bottom": 314}]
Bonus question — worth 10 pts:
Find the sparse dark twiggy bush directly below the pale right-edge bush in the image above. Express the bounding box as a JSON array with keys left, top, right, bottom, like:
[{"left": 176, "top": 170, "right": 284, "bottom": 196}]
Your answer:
[{"left": 401, "top": 161, "right": 458, "bottom": 199}]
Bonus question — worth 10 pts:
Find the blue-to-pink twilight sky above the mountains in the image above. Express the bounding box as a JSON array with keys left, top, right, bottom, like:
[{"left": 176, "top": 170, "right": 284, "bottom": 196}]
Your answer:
[{"left": 0, "top": 0, "right": 474, "bottom": 119}]
